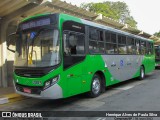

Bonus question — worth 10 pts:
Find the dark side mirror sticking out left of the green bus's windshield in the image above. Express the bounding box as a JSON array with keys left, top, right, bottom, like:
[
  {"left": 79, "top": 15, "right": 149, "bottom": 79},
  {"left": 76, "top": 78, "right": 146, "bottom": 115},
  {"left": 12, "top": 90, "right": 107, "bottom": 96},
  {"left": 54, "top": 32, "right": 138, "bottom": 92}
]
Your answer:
[{"left": 7, "top": 33, "right": 17, "bottom": 53}]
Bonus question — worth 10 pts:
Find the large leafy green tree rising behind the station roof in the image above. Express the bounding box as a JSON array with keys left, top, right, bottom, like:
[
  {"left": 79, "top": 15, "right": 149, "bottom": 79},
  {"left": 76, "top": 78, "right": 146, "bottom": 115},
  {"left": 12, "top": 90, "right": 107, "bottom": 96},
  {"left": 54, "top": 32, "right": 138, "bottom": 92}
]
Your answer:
[{"left": 80, "top": 1, "right": 137, "bottom": 28}]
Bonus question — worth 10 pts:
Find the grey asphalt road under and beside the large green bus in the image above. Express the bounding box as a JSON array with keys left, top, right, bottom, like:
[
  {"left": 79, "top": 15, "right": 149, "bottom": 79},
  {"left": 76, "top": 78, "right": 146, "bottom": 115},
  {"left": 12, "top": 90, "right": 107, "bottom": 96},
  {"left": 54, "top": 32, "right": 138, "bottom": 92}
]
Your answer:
[{"left": 0, "top": 70, "right": 160, "bottom": 120}]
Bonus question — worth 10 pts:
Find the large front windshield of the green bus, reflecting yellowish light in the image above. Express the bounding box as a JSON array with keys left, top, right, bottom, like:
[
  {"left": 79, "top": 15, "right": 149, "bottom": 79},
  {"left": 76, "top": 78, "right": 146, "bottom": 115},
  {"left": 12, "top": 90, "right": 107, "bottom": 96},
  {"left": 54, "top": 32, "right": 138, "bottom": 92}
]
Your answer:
[{"left": 14, "top": 28, "right": 60, "bottom": 67}]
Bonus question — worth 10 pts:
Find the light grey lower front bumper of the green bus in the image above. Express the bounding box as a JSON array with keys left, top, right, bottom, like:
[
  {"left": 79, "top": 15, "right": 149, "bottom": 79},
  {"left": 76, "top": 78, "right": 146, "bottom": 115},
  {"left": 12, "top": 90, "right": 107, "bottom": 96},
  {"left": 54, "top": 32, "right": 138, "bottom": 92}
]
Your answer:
[{"left": 14, "top": 84, "right": 63, "bottom": 99}]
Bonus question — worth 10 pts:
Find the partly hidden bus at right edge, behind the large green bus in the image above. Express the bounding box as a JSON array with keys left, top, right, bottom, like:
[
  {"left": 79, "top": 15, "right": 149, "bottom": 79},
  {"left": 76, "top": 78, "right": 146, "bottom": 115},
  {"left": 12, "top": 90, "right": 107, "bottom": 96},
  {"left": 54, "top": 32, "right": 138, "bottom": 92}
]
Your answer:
[{"left": 154, "top": 45, "right": 160, "bottom": 68}]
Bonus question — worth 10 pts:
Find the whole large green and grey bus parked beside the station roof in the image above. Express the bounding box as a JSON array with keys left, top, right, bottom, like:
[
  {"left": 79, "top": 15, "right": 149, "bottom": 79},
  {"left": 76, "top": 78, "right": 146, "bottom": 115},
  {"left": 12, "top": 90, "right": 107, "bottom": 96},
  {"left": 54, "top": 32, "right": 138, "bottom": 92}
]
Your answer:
[{"left": 8, "top": 13, "right": 155, "bottom": 99}]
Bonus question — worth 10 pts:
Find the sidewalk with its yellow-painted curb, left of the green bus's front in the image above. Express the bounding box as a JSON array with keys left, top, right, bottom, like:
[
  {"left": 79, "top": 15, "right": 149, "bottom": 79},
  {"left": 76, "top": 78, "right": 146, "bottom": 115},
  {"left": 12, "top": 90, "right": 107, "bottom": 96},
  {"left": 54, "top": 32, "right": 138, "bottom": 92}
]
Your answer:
[{"left": 0, "top": 87, "right": 24, "bottom": 105}]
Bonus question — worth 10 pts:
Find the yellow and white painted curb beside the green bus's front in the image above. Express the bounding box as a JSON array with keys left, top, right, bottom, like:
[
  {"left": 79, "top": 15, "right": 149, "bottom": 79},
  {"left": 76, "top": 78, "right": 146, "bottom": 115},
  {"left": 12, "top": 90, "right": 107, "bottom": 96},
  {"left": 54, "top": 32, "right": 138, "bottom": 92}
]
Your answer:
[{"left": 0, "top": 93, "right": 25, "bottom": 105}]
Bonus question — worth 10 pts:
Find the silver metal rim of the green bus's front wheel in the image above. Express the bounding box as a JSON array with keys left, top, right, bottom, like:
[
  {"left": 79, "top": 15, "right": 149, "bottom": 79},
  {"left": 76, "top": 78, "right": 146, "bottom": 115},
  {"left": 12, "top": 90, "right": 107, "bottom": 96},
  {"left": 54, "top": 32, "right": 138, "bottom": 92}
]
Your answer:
[{"left": 92, "top": 78, "right": 100, "bottom": 94}]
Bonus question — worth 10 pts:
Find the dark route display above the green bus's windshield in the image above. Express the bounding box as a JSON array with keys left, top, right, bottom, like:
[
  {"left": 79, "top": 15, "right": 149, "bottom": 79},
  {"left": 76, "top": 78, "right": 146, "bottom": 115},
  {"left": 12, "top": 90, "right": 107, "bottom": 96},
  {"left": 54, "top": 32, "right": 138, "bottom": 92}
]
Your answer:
[{"left": 21, "top": 18, "right": 51, "bottom": 30}]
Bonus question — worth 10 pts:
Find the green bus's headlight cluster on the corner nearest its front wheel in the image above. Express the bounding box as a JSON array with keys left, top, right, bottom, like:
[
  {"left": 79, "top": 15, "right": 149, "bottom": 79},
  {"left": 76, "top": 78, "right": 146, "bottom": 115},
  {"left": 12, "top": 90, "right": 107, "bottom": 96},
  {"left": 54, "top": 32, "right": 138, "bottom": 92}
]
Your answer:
[{"left": 43, "top": 75, "right": 60, "bottom": 89}]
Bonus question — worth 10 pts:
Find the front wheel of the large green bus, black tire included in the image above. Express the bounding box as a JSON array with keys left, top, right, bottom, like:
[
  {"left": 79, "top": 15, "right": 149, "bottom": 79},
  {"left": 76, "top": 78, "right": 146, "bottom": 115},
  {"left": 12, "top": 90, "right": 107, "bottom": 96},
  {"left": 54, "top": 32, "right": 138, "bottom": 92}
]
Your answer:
[{"left": 88, "top": 74, "right": 102, "bottom": 98}]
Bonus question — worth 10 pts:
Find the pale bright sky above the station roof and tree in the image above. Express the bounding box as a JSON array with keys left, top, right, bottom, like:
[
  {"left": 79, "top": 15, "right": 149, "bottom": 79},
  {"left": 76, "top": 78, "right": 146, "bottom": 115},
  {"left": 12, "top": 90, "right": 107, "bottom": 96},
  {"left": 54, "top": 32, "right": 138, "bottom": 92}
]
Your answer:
[{"left": 62, "top": 0, "right": 160, "bottom": 34}]
